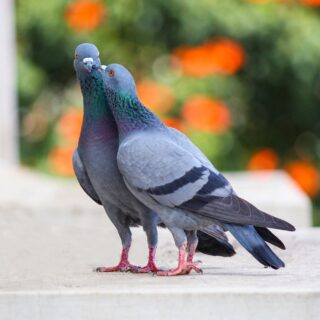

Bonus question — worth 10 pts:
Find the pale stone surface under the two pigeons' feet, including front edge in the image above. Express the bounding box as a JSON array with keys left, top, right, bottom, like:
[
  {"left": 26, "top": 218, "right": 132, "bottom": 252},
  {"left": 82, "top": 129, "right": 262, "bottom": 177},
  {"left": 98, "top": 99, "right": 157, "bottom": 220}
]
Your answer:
[{"left": 0, "top": 167, "right": 320, "bottom": 320}]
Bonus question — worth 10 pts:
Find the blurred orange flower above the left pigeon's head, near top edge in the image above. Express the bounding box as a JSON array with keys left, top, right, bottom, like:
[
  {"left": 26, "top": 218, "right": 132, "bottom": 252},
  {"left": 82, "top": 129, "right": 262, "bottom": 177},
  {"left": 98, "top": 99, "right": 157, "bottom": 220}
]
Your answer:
[{"left": 65, "top": 0, "right": 106, "bottom": 31}]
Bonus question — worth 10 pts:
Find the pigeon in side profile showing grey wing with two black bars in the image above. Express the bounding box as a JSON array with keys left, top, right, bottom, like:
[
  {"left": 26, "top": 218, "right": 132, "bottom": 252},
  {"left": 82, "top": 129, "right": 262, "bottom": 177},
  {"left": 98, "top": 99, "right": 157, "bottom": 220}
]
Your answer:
[{"left": 104, "top": 64, "right": 295, "bottom": 276}]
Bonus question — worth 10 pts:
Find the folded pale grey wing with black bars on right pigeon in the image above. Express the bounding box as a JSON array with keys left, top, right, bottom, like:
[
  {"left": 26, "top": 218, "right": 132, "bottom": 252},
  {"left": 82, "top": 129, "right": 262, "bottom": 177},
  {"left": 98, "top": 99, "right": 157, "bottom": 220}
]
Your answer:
[{"left": 118, "top": 132, "right": 293, "bottom": 230}]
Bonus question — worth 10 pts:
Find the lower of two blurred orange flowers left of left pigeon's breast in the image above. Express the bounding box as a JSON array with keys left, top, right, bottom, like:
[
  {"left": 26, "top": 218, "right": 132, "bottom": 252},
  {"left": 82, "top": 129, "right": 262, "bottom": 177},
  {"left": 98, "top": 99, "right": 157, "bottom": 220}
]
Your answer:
[{"left": 48, "top": 146, "right": 74, "bottom": 176}]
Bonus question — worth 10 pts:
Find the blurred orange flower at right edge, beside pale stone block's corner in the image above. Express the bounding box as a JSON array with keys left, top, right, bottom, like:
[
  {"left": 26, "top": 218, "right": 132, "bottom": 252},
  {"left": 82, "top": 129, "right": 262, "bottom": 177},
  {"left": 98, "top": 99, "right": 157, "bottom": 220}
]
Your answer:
[{"left": 285, "top": 161, "right": 319, "bottom": 197}]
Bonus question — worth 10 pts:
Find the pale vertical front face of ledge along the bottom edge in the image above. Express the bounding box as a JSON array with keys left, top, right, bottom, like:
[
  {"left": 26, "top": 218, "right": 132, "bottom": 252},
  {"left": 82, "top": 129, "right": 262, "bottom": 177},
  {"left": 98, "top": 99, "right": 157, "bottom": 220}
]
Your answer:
[{"left": 0, "top": 290, "right": 320, "bottom": 320}]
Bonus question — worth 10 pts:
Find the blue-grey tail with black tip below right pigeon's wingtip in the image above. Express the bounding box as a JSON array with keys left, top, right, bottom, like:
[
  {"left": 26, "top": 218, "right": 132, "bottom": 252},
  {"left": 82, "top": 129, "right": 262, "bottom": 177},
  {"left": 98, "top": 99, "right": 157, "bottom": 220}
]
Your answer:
[{"left": 225, "top": 224, "right": 285, "bottom": 269}]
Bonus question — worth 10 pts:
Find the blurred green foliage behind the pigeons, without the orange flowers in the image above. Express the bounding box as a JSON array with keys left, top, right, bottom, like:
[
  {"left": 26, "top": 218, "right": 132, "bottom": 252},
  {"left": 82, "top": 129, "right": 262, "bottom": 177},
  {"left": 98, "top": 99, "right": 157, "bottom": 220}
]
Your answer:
[{"left": 16, "top": 0, "right": 320, "bottom": 221}]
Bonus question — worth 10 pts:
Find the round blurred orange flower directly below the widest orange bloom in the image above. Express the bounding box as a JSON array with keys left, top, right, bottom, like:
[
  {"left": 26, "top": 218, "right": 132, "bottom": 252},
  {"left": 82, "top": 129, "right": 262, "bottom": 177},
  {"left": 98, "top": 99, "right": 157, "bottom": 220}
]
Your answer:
[{"left": 182, "top": 96, "right": 231, "bottom": 133}]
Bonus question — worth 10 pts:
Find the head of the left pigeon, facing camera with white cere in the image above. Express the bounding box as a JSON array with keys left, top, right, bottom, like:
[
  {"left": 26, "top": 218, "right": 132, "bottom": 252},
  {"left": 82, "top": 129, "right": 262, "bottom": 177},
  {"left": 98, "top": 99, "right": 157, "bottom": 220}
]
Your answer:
[{"left": 73, "top": 43, "right": 101, "bottom": 78}]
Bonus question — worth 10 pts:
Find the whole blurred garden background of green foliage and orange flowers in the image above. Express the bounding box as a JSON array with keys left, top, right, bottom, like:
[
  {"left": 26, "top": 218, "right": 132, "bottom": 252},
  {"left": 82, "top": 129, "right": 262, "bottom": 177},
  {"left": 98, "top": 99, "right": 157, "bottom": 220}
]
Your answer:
[{"left": 10, "top": 0, "right": 320, "bottom": 224}]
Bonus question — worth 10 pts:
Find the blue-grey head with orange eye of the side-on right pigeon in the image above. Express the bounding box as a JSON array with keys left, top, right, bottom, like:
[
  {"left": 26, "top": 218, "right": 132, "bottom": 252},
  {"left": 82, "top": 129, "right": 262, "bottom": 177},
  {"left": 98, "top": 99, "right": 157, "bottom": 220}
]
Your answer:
[{"left": 105, "top": 63, "right": 137, "bottom": 98}]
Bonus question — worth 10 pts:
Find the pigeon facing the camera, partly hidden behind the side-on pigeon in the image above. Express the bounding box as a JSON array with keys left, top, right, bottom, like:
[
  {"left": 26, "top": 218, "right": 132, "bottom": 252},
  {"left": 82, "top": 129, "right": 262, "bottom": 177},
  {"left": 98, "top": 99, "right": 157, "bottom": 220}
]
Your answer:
[{"left": 73, "top": 43, "right": 235, "bottom": 273}]
